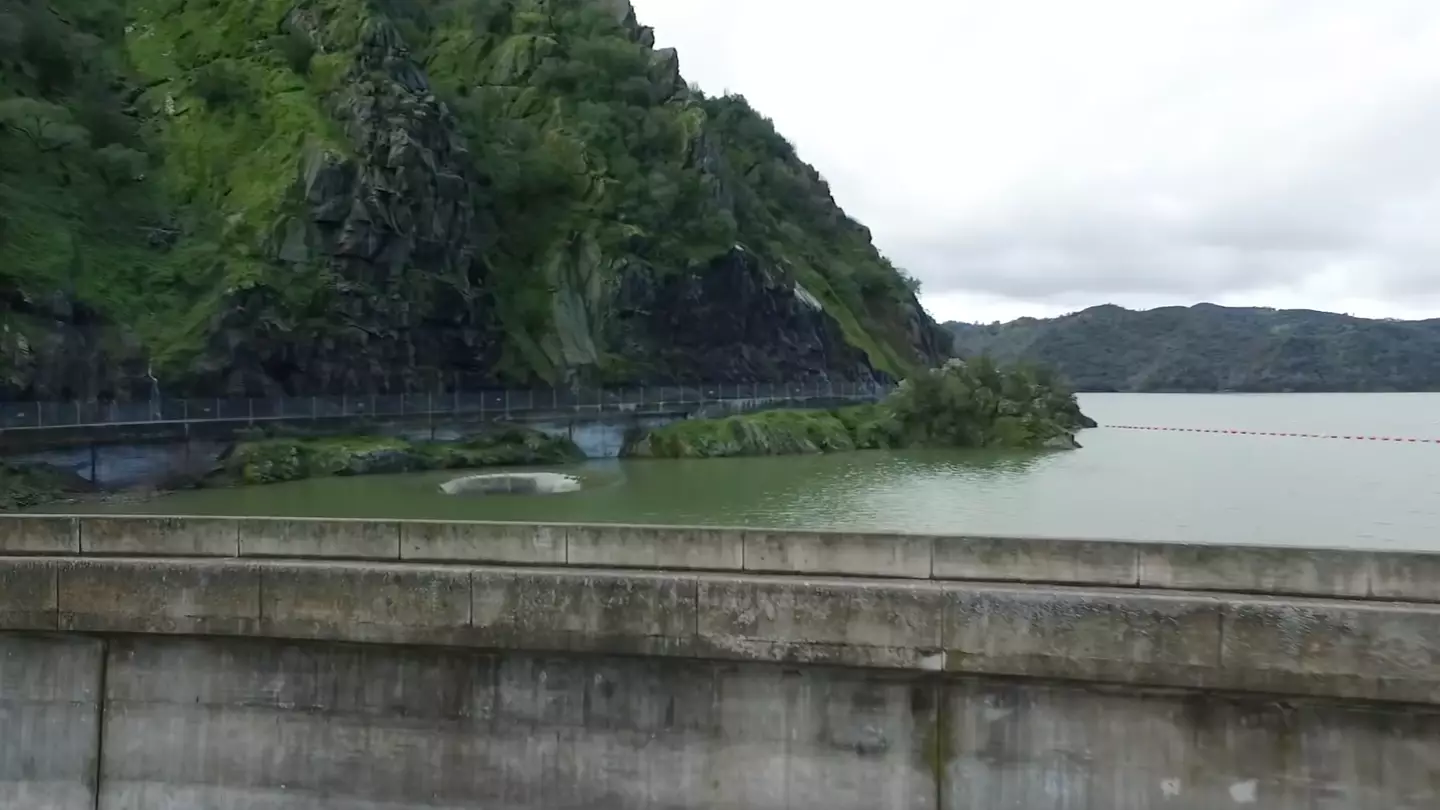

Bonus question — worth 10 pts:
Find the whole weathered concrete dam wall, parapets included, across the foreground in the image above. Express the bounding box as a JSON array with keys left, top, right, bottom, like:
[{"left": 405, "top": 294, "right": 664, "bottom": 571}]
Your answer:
[{"left": 0, "top": 517, "right": 1440, "bottom": 810}]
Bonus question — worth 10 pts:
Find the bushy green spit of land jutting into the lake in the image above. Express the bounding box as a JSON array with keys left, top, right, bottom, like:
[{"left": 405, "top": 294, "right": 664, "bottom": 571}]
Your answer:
[{"left": 625, "top": 357, "right": 1094, "bottom": 458}]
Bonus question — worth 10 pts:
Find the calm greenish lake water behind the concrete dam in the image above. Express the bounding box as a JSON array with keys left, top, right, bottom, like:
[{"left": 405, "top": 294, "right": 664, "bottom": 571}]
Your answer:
[{"left": 61, "top": 393, "right": 1440, "bottom": 549}]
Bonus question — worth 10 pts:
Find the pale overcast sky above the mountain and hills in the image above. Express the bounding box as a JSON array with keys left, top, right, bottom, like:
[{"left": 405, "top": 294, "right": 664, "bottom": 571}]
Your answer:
[{"left": 632, "top": 0, "right": 1440, "bottom": 321}]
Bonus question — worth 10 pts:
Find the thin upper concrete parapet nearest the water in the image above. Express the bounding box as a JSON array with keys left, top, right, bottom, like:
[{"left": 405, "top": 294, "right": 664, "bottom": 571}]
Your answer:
[{"left": 8, "top": 515, "right": 1440, "bottom": 602}]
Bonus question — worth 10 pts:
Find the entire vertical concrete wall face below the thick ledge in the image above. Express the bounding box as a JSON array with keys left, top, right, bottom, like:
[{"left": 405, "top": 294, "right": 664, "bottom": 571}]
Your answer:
[{"left": 0, "top": 634, "right": 1440, "bottom": 810}]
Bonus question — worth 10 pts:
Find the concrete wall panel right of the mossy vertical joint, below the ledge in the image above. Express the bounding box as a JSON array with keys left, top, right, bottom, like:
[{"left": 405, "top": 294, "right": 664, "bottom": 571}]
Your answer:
[{"left": 942, "top": 679, "right": 1440, "bottom": 810}]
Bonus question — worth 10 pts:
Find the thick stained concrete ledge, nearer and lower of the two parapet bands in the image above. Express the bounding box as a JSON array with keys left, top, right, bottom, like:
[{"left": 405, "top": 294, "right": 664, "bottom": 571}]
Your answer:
[{"left": 8, "top": 556, "right": 1440, "bottom": 703}]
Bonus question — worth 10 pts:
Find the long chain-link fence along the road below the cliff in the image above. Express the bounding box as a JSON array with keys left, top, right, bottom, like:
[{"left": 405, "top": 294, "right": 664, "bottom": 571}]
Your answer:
[{"left": 0, "top": 380, "right": 891, "bottom": 430}]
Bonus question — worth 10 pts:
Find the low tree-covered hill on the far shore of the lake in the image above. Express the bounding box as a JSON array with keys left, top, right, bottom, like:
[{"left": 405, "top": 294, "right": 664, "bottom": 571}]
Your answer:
[{"left": 945, "top": 304, "right": 1440, "bottom": 392}]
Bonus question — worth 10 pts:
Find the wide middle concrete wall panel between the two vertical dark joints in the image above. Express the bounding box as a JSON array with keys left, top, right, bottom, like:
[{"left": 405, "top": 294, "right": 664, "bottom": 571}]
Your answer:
[{"left": 101, "top": 638, "right": 937, "bottom": 810}]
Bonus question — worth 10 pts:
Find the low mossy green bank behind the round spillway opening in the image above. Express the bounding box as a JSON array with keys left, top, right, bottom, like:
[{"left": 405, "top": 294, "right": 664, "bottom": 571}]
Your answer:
[{"left": 207, "top": 427, "right": 583, "bottom": 486}]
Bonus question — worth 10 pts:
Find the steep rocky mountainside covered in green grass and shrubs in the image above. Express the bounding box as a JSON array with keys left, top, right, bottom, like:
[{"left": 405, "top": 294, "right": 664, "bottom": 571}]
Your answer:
[{"left": 0, "top": 0, "right": 949, "bottom": 399}]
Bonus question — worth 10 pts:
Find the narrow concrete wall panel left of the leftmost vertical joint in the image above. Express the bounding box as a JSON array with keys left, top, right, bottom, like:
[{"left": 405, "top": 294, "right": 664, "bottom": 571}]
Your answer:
[{"left": 0, "top": 634, "right": 104, "bottom": 810}]
